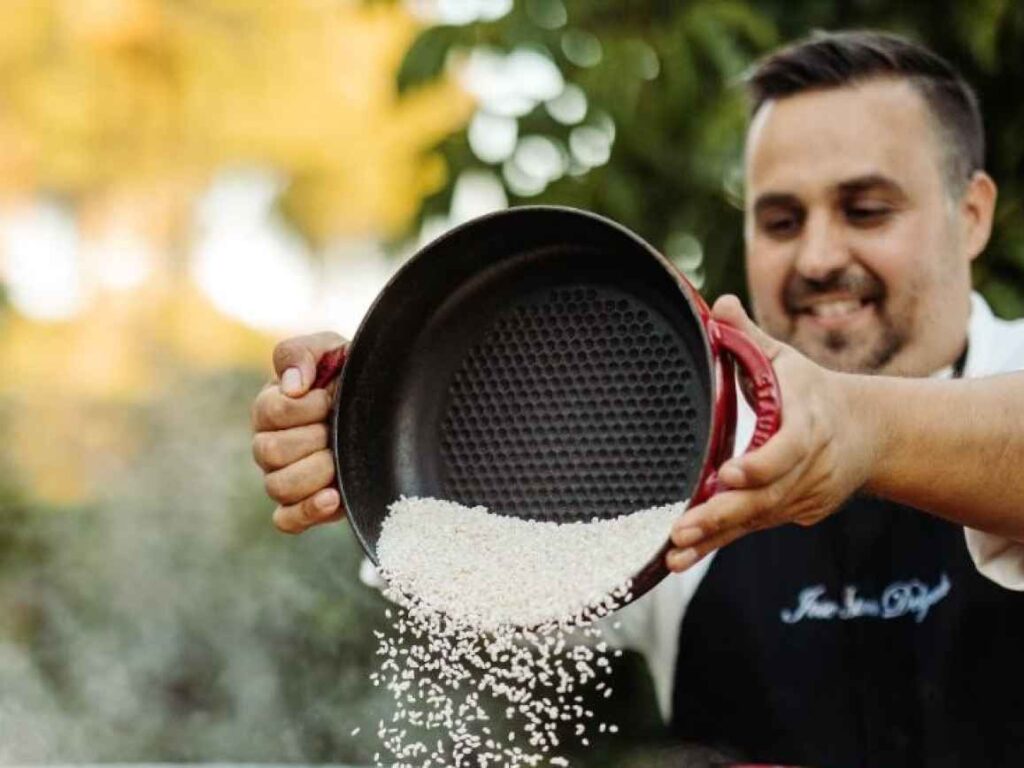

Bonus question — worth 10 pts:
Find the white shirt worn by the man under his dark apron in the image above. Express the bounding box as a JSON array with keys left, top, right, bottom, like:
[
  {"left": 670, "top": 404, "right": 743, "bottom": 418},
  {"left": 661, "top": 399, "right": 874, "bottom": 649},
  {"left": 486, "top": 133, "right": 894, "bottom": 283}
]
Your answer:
[{"left": 613, "top": 294, "right": 1024, "bottom": 719}]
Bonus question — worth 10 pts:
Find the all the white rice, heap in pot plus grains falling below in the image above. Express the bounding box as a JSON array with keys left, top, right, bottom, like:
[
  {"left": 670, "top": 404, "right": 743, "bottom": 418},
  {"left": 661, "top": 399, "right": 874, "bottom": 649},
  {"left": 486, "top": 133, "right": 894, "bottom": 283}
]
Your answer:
[{"left": 373, "top": 498, "right": 686, "bottom": 768}]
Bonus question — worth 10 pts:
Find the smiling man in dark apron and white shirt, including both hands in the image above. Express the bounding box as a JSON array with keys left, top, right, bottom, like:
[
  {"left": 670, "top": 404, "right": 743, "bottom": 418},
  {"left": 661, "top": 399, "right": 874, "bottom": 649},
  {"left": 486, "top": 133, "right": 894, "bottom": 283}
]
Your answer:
[{"left": 254, "top": 33, "right": 1024, "bottom": 766}]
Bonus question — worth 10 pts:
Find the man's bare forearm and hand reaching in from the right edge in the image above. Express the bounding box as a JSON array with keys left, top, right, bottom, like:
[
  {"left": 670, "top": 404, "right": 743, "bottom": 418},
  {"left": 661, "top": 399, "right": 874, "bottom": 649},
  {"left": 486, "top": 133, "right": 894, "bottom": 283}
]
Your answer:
[{"left": 668, "top": 297, "right": 1024, "bottom": 570}]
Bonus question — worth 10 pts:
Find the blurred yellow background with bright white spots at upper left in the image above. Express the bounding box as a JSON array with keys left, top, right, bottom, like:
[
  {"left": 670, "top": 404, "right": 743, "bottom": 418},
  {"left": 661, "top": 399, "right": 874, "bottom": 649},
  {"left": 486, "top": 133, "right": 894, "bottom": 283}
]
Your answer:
[{"left": 0, "top": 0, "right": 471, "bottom": 502}]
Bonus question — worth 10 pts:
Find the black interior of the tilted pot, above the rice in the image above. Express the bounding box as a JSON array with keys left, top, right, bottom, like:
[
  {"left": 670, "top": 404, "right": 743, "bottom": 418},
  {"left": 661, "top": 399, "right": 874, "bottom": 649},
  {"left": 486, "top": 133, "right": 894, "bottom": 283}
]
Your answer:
[{"left": 333, "top": 209, "right": 712, "bottom": 559}]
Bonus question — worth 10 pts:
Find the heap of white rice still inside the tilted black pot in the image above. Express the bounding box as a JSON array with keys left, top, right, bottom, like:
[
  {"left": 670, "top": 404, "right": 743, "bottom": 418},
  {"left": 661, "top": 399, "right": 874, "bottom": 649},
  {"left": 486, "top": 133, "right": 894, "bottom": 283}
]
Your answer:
[{"left": 377, "top": 498, "right": 686, "bottom": 631}]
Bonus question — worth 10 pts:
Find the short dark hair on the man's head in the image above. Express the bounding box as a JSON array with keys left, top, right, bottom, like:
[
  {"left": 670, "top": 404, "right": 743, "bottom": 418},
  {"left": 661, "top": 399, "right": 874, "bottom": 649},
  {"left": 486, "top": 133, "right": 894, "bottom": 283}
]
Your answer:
[{"left": 745, "top": 31, "right": 985, "bottom": 194}]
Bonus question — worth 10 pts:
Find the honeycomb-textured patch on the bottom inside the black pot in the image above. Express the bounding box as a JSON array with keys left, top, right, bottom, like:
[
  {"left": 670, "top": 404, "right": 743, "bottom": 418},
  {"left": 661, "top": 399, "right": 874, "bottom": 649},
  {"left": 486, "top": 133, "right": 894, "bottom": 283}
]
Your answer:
[{"left": 440, "top": 286, "right": 707, "bottom": 522}]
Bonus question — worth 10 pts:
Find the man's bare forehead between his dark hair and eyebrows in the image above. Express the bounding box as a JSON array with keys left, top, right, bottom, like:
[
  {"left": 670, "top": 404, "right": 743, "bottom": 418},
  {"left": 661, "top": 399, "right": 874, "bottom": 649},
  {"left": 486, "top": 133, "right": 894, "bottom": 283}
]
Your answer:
[{"left": 745, "top": 80, "right": 942, "bottom": 200}]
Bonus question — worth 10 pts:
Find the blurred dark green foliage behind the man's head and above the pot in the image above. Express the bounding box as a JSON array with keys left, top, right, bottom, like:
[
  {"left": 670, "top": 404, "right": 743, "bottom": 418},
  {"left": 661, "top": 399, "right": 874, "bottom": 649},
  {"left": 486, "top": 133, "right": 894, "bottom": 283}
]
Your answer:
[{"left": 398, "top": 0, "right": 1024, "bottom": 316}]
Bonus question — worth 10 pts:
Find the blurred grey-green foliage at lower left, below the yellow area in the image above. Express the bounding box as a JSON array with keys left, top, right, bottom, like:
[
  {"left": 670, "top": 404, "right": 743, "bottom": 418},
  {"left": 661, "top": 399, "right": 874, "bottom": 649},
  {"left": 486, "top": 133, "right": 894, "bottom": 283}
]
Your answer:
[{"left": 0, "top": 373, "right": 389, "bottom": 765}]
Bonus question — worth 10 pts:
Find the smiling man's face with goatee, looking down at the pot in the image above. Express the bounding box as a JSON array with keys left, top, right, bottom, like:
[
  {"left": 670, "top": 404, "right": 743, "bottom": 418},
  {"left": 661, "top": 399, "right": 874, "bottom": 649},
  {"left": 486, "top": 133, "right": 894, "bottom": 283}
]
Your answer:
[{"left": 744, "top": 80, "right": 971, "bottom": 376}]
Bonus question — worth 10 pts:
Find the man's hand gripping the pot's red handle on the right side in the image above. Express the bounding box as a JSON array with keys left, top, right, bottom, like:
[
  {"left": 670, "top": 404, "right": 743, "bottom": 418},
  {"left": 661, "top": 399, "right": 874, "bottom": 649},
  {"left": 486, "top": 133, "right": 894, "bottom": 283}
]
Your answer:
[{"left": 667, "top": 296, "right": 878, "bottom": 571}]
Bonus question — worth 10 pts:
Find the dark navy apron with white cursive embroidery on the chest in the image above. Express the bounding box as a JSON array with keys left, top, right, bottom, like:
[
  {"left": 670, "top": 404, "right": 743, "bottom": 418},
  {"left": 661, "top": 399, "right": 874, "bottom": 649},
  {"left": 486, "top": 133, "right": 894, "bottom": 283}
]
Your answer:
[{"left": 672, "top": 356, "right": 1024, "bottom": 768}]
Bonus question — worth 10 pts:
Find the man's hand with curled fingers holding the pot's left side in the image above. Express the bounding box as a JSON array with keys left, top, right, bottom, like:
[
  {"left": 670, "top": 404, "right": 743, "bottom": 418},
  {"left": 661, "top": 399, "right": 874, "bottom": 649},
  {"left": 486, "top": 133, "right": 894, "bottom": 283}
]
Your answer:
[{"left": 252, "top": 333, "right": 348, "bottom": 534}]
